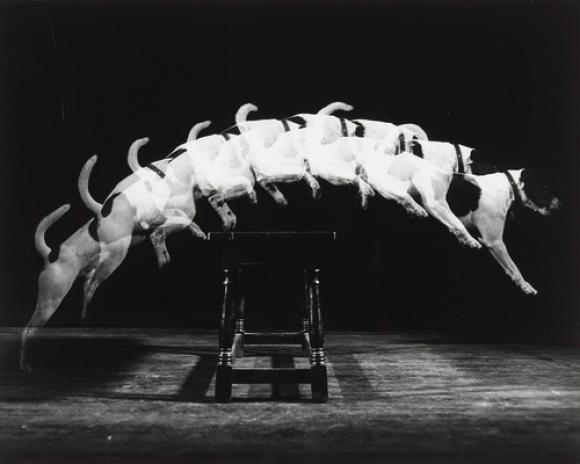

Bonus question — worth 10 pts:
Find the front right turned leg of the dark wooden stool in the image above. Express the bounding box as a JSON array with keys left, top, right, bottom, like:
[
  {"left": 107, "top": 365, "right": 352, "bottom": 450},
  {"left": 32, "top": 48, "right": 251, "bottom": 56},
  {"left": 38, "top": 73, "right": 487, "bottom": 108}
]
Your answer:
[{"left": 308, "top": 269, "right": 328, "bottom": 403}]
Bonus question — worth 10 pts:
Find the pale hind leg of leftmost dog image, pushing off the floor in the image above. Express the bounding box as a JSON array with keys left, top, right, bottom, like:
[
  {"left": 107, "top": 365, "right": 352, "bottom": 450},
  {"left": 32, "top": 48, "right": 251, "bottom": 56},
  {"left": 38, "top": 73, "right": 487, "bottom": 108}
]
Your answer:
[{"left": 20, "top": 261, "right": 79, "bottom": 371}]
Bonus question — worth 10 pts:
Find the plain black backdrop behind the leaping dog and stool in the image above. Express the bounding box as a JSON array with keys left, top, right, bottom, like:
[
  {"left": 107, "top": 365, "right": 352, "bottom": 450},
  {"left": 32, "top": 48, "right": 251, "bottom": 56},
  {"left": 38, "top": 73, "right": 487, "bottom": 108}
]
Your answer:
[{"left": 0, "top": 1, "right": 580, "bottom": 334}]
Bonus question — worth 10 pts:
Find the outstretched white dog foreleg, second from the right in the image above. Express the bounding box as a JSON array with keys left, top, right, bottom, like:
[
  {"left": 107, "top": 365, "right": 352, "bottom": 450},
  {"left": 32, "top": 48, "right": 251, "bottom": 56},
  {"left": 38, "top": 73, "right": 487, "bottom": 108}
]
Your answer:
[{"left": 411, "top": 172, "right": 481, "bottom": 249}]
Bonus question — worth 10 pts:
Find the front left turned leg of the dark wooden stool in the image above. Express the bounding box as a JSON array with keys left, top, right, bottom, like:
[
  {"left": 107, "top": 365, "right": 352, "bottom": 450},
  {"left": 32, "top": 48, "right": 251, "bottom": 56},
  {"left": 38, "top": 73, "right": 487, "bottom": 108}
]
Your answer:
[{"left": 215, "top": 268, "right": 234, "bottom": 403}]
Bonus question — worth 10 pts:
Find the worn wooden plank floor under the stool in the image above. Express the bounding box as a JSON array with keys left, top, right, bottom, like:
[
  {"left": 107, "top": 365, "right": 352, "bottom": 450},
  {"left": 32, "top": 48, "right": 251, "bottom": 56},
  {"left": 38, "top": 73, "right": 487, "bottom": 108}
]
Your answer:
[{"left": 0, "top": 328, "right": 580, "bottom": 463}]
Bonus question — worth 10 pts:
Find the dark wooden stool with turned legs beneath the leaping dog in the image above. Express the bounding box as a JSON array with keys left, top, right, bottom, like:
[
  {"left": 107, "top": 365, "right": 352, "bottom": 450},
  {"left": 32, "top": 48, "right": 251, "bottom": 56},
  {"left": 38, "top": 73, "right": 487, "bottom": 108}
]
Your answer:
[{"left": 209, "top": 232, "right": 336, "bottom": 403}]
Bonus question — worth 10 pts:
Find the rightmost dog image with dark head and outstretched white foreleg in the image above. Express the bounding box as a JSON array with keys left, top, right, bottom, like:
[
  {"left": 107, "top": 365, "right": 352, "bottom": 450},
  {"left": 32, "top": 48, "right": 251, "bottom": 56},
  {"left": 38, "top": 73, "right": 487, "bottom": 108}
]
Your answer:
[{"left": 447, "top": 169, "right": 560, "bottom": 295}]
